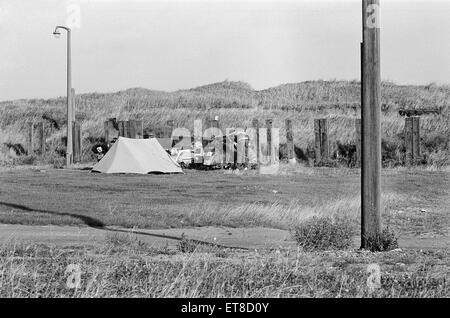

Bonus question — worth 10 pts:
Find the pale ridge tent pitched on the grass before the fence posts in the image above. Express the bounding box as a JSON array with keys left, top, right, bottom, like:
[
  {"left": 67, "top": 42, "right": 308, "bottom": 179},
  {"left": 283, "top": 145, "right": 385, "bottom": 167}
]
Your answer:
[{"left": 92, "top": 137, "right": 183, "bottom": 174}]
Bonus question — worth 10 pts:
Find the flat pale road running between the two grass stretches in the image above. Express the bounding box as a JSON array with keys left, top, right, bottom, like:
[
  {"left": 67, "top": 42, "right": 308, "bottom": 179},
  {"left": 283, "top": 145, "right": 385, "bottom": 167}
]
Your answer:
[{"left": 0, "top": 224, "right": 450, "bottom": 250}]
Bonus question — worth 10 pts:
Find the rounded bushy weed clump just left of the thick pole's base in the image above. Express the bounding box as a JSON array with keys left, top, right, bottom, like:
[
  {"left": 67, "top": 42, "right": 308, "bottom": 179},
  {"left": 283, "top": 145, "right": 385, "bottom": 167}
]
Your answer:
[{"left": 293, "top": 216, "right": 354, "bottom": 251}]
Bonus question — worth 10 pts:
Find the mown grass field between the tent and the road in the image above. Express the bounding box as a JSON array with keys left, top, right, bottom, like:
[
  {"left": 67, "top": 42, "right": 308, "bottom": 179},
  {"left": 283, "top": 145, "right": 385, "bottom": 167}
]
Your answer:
[{"left": 0, "top": 168, "right": 450, "bottom": 234}]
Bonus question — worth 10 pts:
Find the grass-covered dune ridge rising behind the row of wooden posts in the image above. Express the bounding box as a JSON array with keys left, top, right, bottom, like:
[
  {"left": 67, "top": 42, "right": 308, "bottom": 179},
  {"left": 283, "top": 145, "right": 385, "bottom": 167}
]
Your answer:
[{"left": 0, "top": 81, "right": 450, "bottom": 166}]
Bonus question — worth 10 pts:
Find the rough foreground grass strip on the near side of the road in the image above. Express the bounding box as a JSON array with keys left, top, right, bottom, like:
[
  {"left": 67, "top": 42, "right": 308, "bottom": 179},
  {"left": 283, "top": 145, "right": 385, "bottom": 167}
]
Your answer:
[{"left": 0, "top": 241, "right": 450, "bottom": 297}]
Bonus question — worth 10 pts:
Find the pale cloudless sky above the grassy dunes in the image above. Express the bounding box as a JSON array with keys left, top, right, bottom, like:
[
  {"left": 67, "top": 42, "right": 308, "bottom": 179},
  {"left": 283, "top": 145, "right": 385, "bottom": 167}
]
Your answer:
[{"left": 0, "top": 0, "right": 450, "bottom": 100}]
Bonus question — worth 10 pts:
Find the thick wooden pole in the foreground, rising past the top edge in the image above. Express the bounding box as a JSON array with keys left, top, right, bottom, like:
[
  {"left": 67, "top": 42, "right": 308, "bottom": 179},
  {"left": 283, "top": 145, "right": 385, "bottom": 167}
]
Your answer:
[{"left": 361, "top": 0, "right": 382, "bottom": 248}]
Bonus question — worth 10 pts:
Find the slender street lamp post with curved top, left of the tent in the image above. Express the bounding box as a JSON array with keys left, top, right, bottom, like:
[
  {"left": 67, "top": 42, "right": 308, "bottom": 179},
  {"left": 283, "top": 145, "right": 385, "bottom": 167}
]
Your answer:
[{"left": 53, "top": 25, "right": 74, "bottom": 168}]
